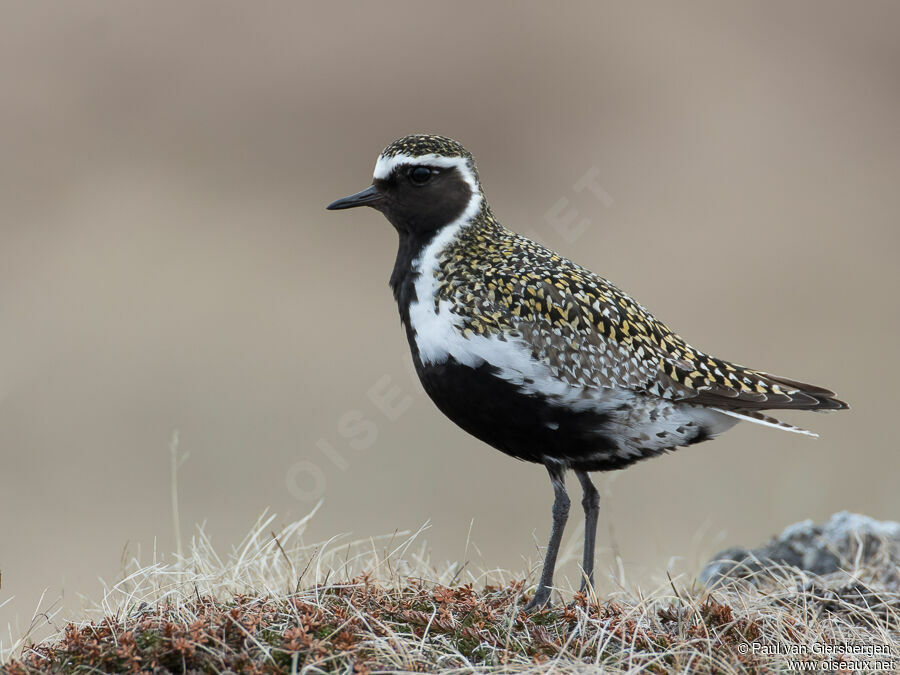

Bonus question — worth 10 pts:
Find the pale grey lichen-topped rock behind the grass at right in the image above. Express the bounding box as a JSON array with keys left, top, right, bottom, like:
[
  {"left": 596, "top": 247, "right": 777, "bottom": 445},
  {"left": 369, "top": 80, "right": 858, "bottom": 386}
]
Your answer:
[{"left": 700, "top": 511, "right": 900, "bottom": 587}]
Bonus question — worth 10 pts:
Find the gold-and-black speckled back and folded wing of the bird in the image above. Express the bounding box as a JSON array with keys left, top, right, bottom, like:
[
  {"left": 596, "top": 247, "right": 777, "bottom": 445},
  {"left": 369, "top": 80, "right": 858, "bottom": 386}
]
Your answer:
[{"left": 434, "top": 206, "right": 843, "bottom": 418}]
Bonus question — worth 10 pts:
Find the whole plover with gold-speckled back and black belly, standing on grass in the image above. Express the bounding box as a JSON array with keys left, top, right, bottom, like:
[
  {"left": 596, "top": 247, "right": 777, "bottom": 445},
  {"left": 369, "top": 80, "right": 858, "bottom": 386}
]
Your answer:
[{"left": 326, "top": 134, "right": 849, "bottom": 612}]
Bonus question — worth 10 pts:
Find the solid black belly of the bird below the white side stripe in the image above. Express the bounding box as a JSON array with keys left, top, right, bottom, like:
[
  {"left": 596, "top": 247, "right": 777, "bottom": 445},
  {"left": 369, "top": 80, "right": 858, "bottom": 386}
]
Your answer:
[{"left": 415, "top": 358, "right": 657, "bottom": 471}]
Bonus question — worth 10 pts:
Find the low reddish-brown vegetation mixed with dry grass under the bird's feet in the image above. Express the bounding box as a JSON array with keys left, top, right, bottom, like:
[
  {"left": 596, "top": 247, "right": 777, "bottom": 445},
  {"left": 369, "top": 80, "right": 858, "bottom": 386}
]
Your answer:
[{"left": 2, "top": 577, "right": 772, "bottom": 675}]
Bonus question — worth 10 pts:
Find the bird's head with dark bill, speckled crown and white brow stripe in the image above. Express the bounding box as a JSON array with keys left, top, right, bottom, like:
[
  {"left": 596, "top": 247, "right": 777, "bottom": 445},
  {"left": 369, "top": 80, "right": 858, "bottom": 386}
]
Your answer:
[{"left": 327, "top": 134, "right": 484, "bottom": 235}]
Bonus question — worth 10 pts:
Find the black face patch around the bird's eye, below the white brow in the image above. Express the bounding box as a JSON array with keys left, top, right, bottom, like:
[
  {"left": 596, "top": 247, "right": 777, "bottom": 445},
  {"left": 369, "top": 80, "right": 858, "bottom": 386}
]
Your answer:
[{"left": 374, "top": 164, "right": 472, "bottom": 234}]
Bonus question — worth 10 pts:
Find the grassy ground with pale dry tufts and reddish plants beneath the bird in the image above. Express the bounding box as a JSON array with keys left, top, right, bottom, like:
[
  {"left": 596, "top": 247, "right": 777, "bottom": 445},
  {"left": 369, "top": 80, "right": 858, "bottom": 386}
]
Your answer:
[{"left": 2, "top": 518, "right": 900, "bottom": 674}]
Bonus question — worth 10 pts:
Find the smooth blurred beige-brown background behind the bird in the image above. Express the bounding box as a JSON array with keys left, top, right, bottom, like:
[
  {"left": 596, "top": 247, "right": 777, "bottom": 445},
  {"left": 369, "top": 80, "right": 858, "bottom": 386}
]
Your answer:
[{"left": 0, "top": 0, "right": 900, "bottom": 644}]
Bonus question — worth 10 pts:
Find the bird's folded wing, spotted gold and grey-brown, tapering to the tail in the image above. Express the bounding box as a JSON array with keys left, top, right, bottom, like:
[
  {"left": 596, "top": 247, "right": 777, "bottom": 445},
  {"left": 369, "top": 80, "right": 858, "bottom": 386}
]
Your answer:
[{"left": 495, "top": 274, "right": 847, "bottom": 411}]
